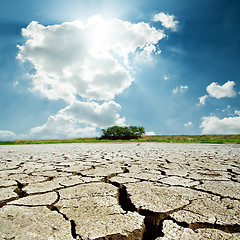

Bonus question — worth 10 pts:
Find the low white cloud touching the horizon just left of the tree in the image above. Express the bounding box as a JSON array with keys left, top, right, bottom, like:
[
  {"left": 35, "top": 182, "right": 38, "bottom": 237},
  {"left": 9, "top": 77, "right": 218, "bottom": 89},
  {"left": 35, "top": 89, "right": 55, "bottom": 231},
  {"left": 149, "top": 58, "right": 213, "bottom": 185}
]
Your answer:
[{"left": 29, "top": 115, "right": 99, "bottom": 139}]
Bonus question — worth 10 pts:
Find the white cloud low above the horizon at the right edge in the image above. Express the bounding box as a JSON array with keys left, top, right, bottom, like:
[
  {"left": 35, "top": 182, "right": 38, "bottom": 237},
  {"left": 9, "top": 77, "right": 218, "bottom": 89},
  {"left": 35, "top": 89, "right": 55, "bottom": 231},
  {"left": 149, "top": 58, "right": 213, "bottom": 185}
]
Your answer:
[{"left": 200, "top": 116, "right": 240, "bottom": 134}]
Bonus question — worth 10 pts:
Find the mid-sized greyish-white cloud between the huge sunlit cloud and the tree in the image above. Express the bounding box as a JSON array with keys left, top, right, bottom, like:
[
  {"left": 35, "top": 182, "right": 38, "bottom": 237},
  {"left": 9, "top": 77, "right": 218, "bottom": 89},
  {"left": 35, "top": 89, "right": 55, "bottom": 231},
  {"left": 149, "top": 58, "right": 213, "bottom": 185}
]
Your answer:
[{"left": 59, "top": 101, "right": 125, "bottom": 128}]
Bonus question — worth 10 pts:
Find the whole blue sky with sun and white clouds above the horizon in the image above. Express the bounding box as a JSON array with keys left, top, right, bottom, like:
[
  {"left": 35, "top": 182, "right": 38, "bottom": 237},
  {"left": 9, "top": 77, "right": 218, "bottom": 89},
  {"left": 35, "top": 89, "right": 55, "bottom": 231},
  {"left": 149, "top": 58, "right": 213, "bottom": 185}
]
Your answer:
[{"left": 0, "top": 0, "right": 240, "bottom": 140}]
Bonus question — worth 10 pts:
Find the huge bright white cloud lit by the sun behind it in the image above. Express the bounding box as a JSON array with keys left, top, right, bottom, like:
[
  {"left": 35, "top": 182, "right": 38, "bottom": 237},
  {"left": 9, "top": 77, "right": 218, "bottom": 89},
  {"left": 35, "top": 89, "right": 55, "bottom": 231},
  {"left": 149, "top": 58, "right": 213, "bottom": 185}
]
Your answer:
[{"left": 17, "top": 16, "right": 165, "bottom": 102}]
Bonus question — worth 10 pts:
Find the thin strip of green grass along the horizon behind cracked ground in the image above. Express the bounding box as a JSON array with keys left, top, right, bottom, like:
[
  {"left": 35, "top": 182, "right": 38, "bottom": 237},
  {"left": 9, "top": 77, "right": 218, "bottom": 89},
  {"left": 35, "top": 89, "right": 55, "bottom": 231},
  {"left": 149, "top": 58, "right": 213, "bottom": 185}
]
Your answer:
[{"left": 0, "top": 135, "right": 240, "bottom": 145}]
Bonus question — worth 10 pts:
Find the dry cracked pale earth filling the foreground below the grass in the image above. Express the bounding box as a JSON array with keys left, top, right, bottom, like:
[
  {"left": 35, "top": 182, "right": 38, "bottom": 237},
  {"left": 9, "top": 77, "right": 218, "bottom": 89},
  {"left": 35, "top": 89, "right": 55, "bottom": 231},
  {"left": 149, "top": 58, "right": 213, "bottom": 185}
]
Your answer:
[{"left": 0, "top": 143, "right": 240, "bottom": 240}]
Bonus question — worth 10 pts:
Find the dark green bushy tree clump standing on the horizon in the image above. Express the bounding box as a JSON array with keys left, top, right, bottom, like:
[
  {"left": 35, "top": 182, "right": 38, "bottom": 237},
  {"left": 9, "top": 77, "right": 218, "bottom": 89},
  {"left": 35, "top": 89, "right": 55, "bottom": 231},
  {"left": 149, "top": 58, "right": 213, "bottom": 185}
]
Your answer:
[{"left": 101, "top": 126, "right": 145, "bottom": 140}]
